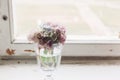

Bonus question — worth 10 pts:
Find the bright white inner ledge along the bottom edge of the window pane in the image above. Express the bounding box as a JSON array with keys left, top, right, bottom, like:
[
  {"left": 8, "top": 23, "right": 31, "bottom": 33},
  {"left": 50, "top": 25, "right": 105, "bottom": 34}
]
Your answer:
[{"left": 12, "top": 35, "right": 120, "bottom": 44}]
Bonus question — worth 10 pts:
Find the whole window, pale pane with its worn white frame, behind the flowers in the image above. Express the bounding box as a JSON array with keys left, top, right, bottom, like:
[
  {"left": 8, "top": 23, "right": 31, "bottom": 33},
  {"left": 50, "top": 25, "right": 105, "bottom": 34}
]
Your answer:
[{"left": 0, "top": 0, "right": 120, "bottom": 56}]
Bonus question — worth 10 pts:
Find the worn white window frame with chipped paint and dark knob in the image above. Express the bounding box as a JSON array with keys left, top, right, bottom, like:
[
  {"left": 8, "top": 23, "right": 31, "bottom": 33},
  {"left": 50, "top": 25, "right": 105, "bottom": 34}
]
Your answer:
[{"left": 0, "top": 0, "right": 120, "bottom": 56}]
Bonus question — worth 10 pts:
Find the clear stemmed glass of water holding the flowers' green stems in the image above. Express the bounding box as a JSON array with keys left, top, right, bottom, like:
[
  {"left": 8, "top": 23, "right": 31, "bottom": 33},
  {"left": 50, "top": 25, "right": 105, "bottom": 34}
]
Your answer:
[{"left": 36, "top": 44, "right": 62, "bottom": 80}]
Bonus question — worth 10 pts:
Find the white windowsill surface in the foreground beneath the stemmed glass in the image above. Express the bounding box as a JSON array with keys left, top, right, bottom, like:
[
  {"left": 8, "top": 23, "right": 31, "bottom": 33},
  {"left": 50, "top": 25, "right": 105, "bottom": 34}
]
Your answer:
[{"left": 0, "top": 60, "right": 120, "bottom": 80}]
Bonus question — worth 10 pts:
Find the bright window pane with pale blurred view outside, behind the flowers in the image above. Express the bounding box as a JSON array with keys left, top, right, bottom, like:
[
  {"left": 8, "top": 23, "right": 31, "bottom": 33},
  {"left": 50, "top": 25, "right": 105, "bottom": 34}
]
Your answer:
[{"left": 12, "top": 0, "right": 120, "bottom": 39}]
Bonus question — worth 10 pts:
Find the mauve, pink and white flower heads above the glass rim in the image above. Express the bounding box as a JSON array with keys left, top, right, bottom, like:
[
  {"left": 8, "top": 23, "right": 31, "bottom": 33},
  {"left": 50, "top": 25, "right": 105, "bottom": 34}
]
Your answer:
[{"left": 28, "top": 23, "right": 66, "bottom": 48}]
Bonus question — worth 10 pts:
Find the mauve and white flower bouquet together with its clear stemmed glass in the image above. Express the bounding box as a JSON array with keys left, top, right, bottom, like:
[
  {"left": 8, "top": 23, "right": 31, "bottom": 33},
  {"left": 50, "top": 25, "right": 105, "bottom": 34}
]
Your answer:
[{"left": 28, "top": 22, "right": 66, "bottom": 80}]
